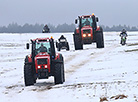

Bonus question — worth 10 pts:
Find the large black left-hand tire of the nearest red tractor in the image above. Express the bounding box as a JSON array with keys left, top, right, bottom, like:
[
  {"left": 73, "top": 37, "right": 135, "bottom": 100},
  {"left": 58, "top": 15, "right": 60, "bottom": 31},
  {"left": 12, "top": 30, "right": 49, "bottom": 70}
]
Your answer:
[{"left": 24, "top": 64, "right": 36, "bottom": 86}]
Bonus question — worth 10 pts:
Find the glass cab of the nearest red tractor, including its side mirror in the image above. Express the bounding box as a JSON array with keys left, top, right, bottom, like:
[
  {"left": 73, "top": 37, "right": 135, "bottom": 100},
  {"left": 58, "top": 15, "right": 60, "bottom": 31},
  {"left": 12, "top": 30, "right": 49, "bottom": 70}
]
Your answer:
[{"left": 26, "top": 38, "right": 55, "bottom": 59}]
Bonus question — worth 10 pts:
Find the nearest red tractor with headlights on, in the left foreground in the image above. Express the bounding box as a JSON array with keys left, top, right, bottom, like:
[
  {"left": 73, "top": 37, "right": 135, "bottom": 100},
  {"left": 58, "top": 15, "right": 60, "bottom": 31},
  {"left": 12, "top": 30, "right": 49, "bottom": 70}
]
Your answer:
[{"left": 24, "top": 38, "right": 65, "bottom": 86}]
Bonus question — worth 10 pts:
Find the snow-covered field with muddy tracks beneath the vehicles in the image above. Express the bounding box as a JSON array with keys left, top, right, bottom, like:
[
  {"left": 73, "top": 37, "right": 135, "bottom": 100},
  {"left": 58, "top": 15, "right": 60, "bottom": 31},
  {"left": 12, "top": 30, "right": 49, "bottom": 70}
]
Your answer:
[{"left": 0, "top": 32, "right": 138, "bottom": 102}]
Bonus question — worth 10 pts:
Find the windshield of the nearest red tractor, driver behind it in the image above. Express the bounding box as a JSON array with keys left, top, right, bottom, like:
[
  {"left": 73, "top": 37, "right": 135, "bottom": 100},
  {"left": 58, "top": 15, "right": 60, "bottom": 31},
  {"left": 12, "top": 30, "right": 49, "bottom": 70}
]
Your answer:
[{"left": 35, "top": 42, "right": 50, "bottom": 54}]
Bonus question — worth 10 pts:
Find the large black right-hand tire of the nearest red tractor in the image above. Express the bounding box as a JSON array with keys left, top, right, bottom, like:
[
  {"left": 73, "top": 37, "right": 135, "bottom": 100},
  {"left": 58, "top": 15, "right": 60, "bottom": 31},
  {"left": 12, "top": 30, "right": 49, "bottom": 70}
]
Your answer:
[{"left": 54, "top": 55, "right": 65, "bottom": 84}]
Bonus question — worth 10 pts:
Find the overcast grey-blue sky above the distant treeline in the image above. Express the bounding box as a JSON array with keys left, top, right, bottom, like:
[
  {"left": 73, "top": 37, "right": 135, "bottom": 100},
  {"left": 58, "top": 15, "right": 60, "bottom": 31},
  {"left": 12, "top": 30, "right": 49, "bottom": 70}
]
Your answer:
[{"left": 0, "top": 0, "right": 138, "bottom": 26}]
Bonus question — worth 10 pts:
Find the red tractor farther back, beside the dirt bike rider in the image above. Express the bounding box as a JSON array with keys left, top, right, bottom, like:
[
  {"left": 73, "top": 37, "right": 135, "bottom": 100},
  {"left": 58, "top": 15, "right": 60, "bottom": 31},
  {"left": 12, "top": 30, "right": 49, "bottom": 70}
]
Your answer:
[{"left": 73, "top": 14, "right": 104, "bottom": 50}]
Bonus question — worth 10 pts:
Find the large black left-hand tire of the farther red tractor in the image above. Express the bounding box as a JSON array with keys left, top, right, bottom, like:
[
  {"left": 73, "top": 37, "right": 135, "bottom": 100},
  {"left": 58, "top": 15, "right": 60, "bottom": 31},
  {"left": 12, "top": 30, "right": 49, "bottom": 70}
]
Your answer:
[{"left": 73, "top": 34, "right": 83, "bottom": 50}]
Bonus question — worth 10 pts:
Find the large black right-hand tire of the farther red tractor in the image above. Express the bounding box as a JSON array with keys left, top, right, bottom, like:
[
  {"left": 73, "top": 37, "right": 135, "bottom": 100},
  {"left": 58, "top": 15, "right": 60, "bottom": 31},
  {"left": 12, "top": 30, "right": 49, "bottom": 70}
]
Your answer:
[{"left": 96, "top": 30, "right": 104, "bottom": 48}]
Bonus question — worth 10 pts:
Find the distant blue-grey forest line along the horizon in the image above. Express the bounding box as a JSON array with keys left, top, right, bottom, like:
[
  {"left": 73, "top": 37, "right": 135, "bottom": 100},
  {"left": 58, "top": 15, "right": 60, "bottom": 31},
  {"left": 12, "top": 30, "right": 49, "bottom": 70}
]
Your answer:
[{"left": 0, "top": 23, "right": 138, "bottom": 33}]
